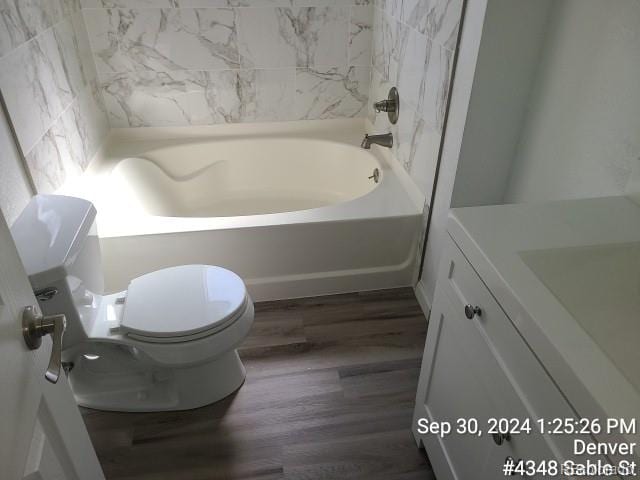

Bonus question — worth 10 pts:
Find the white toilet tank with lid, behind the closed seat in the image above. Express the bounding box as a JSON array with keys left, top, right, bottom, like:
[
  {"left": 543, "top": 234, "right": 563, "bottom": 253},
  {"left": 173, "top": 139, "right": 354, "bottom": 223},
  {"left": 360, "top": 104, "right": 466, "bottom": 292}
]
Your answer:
[{"left": 11, "top": 195, "right": 104, "bottom": 348}]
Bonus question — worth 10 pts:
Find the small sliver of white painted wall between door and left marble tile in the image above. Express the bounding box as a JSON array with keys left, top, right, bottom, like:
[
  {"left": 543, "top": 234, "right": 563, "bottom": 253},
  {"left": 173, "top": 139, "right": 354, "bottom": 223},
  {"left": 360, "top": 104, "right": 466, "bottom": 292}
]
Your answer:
[{"left": 0, "top": 110, "right": 32, "bottom": 225}]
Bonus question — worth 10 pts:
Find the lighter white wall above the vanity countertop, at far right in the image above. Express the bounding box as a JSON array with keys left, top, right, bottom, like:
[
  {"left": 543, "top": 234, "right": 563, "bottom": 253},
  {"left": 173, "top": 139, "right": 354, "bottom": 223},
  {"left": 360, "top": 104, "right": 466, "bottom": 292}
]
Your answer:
[{"left": 505, "top": 0, "right": 640, "bottom": 202}]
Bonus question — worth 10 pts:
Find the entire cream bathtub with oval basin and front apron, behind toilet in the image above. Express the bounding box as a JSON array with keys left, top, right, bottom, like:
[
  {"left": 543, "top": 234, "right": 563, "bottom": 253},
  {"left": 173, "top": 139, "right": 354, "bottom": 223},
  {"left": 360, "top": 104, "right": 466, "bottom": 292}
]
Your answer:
[{"left": 60, "top": 120, "right": 423, "bottom": 300}]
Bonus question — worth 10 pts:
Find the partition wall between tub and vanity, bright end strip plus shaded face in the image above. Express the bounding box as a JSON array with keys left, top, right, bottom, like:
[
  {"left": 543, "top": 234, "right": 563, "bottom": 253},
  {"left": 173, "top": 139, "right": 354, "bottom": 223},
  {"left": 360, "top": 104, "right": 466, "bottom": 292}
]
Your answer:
[{"left": 416, "top": 0, "right": 550, "bottom": 303}]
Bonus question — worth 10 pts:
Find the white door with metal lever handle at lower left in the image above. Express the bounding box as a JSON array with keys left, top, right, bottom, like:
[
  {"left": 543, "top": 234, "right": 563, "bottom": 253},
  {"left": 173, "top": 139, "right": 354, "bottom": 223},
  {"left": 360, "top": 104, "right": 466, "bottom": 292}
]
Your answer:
[{"left": 0, "top": 205, "right": 104, "bottom": 480}]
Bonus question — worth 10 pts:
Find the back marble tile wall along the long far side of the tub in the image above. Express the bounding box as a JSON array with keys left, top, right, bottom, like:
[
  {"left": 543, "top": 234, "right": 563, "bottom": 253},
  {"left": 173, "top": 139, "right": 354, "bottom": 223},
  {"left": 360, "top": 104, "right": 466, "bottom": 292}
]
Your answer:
[{"left": 80, "top": 0, "right": 373, "bottom": 127}]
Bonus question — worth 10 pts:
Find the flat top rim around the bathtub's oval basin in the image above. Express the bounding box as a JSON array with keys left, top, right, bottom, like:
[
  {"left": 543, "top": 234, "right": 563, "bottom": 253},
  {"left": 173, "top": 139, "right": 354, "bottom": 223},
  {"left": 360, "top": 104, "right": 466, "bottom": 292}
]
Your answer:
[{"left": 61, "top": 119, "right": 428, "bottom": 238}]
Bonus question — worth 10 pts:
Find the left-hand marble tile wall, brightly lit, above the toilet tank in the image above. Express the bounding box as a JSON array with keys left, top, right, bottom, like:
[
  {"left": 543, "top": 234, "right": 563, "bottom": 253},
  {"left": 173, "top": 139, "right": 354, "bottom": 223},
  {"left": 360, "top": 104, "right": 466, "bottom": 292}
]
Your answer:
[{"left": 0, "top": 0, "right": 109, "bottom": 193}]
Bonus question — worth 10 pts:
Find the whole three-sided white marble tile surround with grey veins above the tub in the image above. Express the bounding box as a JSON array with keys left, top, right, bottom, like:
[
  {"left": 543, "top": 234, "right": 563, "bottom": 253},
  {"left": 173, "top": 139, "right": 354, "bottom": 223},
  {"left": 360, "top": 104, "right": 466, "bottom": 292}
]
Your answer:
[{"left": 0, "top": 0, "right": 462, "bottom": 201}]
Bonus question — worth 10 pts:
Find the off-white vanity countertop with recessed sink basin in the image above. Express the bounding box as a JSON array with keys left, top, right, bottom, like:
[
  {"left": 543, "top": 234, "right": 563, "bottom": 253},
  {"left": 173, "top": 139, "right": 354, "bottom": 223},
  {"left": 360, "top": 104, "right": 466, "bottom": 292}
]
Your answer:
[{"left": 448, "top": 197, "right": 640, "bottom": 442}]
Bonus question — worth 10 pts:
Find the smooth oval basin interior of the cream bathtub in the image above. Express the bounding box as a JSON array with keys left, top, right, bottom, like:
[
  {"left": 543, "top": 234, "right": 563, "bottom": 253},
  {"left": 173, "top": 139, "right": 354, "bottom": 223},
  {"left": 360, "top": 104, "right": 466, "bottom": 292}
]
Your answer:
[{"left": 110, "top": 138, "right": 380, "bottom": 217}]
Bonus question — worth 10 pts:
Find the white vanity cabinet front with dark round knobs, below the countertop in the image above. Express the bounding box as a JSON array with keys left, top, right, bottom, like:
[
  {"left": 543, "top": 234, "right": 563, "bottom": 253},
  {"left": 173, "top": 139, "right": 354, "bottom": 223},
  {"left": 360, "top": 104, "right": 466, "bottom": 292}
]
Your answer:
[{"left": 413, "top": 233, "right": 611, "bottom": 480}]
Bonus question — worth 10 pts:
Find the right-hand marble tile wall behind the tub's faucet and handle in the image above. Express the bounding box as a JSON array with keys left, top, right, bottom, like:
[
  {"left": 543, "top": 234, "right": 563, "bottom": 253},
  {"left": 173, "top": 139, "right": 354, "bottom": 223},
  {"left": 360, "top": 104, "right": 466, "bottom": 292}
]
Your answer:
[{"left": 368, "top": 0, "right": 463, "bottom": 273}]
